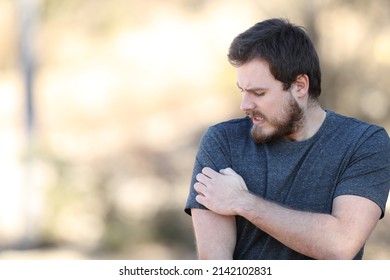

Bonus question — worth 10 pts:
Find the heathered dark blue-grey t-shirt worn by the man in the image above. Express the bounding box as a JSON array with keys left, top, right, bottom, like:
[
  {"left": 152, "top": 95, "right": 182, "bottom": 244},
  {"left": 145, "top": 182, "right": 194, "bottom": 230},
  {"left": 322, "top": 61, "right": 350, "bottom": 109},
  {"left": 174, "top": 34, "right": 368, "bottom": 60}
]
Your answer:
[{"left": 185, "top": 111, "right": 390, "bottom": 259}]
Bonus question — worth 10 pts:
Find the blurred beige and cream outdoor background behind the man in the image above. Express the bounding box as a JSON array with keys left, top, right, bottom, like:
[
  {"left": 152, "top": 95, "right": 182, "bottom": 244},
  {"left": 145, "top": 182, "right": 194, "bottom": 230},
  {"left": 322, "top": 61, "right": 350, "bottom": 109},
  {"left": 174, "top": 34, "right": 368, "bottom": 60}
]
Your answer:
[{"left": 0, "top": 0, "right": 390, "bottom": 259}]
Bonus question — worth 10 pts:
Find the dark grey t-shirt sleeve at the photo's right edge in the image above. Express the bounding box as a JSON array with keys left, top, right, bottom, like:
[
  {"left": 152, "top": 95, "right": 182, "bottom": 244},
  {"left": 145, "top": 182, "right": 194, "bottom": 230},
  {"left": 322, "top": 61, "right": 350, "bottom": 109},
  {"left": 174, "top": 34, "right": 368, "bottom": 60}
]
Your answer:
[{"left": 335, "top": 126, "right": 390, "bottom": 218}]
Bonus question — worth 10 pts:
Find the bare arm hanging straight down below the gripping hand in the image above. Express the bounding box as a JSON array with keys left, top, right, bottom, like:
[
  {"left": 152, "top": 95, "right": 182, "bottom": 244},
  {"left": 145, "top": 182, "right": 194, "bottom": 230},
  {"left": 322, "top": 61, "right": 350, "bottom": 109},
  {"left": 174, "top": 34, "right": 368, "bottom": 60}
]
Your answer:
[{"left": 191, "top": 208, "right": 237, "bottom": 260}]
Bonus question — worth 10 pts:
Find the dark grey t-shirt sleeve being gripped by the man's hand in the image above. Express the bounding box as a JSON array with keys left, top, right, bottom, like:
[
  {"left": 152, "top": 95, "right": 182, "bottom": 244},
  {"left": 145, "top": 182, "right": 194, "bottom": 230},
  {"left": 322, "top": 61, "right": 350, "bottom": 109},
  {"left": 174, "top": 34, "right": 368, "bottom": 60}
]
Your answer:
[{"left": 185, "top": 126, "right": 231, "bottom": 215}]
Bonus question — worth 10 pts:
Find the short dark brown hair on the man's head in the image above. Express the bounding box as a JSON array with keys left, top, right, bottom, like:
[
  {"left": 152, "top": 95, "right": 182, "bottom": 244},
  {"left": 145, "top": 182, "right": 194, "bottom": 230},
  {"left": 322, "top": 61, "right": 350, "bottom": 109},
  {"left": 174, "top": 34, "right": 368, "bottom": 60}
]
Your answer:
[{"left": 228, "top": 18, "right": 321, "bottom": 99}]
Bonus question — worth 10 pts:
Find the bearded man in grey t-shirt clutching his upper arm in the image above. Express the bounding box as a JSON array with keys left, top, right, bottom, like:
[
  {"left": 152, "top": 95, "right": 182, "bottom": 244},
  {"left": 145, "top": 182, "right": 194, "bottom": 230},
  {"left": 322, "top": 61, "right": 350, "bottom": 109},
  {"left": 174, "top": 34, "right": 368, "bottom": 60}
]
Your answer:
[{"left": 185, "top": 19, "right": 390, "bottom": 259}]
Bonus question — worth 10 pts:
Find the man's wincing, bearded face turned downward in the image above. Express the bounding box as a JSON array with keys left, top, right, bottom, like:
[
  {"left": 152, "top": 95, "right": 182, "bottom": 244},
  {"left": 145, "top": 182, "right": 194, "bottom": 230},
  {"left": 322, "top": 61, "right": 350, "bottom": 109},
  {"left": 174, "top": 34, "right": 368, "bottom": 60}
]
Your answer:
[{"left": 237, "top": 60, "right": 304, "bottom": 143}]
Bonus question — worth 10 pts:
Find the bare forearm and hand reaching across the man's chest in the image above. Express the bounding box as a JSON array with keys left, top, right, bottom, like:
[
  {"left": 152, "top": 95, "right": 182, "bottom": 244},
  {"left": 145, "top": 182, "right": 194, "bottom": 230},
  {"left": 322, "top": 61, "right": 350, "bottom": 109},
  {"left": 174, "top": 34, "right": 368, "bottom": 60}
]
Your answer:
[{"left": 195, "top": 168, "right": 381, "bottom": 259}]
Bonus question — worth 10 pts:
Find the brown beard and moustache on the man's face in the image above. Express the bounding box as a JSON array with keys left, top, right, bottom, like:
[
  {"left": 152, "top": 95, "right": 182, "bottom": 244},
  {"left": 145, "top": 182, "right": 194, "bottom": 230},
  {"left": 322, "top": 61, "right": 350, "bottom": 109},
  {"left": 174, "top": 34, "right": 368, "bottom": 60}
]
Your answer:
[{"left": 248, "top": 98, "right": 304, "bottom": 144}]
